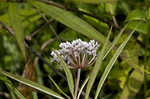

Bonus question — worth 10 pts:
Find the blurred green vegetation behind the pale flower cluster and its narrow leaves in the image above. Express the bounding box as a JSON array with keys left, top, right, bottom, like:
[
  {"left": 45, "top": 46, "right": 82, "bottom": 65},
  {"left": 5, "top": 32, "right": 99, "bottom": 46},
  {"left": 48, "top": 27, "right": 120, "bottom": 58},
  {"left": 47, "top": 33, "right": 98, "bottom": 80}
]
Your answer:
[{"left": 0, "top": 0, "right": 150, "bottom": 99}]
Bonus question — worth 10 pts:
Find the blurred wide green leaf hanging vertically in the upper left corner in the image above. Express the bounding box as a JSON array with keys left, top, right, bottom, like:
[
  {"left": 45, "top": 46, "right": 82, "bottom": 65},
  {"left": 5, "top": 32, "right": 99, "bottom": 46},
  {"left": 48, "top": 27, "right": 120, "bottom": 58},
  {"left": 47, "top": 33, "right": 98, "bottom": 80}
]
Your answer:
[{"left": 8, "top": 3, "right": 25, "bottom": 57}]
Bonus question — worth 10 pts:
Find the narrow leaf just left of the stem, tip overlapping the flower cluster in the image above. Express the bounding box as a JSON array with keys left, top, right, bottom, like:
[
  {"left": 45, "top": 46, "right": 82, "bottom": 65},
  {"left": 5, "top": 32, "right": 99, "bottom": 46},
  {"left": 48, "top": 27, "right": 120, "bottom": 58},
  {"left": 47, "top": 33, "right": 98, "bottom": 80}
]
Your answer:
[{"left": 55, "top": 52, "right": 74, "bottom": 97}]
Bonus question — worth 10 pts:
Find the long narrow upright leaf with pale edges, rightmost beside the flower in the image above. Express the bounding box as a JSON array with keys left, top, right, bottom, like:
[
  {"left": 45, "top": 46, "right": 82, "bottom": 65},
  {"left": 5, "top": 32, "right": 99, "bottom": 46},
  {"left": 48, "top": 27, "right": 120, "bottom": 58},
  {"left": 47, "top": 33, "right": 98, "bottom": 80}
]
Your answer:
[{"left": 95, "top": 30, "right": 135, "bottom": 99}]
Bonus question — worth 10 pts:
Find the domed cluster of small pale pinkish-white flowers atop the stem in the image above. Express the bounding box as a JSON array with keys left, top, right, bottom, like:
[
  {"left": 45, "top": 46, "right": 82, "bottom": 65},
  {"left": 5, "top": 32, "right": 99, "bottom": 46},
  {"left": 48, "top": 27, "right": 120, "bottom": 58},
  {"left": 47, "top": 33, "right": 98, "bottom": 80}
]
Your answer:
[{"left": 51, "top": 39, "right": 99, "bottom": 68}]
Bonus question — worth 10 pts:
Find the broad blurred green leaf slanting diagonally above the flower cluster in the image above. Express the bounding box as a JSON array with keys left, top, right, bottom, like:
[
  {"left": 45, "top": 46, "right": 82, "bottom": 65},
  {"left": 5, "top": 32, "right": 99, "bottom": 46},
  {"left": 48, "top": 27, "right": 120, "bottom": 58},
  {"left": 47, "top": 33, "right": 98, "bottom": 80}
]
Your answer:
[{"left": 31, "top": 1, "right": 105, "bottom": 43}]
